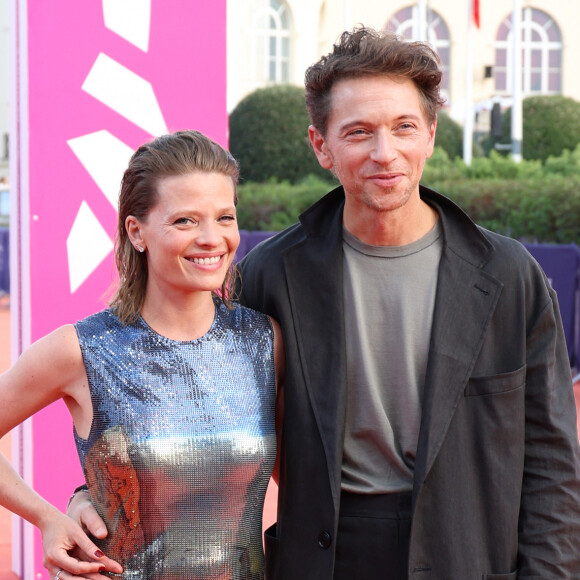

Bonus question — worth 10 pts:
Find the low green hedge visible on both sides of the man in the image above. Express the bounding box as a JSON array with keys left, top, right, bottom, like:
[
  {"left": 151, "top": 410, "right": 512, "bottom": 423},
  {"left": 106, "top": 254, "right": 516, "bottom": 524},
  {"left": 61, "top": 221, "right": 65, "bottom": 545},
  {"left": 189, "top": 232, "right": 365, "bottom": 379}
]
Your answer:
[{"left": 238, "top": 147, "right": 580, "bottom": 245}]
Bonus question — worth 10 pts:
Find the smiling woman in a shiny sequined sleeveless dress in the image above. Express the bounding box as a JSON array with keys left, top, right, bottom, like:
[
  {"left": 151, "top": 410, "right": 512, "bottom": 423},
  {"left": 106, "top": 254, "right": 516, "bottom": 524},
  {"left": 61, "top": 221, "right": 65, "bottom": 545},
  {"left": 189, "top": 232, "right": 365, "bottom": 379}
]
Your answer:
[{"left": 0, "top": 131, "right": 283, "bottom": 580}]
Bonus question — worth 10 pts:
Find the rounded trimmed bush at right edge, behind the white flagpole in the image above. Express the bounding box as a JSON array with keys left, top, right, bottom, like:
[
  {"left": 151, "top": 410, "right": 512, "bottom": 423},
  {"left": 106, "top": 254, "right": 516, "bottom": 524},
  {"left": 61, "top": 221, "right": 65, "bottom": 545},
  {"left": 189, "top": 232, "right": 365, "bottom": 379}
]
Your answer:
[{"left": 502, "top": 95, "right": 580, "bottom": 162}]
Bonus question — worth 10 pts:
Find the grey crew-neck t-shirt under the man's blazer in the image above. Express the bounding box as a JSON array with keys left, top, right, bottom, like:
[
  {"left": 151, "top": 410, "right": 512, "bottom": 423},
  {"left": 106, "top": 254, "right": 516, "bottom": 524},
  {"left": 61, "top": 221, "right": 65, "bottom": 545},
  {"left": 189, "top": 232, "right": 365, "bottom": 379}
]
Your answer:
[{"left": 342, "top": 221, "right": 443, "bottom": 494}]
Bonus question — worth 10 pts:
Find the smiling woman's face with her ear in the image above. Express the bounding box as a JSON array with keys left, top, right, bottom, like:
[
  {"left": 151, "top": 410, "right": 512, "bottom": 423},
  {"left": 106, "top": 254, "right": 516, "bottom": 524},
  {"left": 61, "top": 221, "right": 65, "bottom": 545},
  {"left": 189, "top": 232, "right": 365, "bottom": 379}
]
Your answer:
[{"left": 126, "top": 171, "right": 240, "bottom": 296}]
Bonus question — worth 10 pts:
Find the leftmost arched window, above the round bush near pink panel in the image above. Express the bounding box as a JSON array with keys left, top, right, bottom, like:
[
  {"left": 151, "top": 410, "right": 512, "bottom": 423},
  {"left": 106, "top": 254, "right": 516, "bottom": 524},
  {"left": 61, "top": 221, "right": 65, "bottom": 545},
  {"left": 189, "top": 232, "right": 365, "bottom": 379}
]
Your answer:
[{"left": 254, "top": 0, "right": 290, "bottom": 83}]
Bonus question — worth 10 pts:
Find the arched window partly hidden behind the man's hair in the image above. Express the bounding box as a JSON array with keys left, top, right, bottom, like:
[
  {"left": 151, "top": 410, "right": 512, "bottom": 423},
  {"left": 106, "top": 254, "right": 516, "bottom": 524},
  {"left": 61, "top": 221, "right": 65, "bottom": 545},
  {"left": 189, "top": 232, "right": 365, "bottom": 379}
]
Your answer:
[{"left": 385, "top": 4, "right": 451, "bottom": 98}]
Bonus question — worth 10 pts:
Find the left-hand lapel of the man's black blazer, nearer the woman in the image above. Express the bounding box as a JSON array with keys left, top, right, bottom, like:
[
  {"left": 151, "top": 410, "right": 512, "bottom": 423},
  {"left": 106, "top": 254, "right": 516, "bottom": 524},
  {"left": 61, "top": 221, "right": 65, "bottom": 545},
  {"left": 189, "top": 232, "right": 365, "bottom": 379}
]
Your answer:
[{"left": 283, "top": 212, "right": 346, "bottom": 505}]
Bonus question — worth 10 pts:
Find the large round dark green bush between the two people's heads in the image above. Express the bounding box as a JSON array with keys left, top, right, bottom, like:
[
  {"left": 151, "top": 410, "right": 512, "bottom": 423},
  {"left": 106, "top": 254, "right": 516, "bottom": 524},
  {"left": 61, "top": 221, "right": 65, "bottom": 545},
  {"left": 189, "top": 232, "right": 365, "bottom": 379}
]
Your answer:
[{"left": 229, "top": 85, "right": 332, "bottom": 183}]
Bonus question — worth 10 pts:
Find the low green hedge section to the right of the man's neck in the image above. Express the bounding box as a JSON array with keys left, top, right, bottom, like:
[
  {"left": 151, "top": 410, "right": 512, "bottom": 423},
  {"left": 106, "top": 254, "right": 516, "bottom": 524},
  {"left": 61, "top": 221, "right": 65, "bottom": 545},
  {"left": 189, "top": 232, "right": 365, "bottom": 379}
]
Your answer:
[{"left": 421, "top": 148, "right": 580, "bottom": 244}]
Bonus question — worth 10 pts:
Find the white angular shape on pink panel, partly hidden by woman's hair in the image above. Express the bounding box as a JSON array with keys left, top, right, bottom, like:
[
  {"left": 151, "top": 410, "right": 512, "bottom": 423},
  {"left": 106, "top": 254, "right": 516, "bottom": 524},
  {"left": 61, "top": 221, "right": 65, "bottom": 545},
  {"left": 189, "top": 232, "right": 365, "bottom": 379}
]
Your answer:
[{"left": 67, "top": 129, "right": 133, "bottom": 209}]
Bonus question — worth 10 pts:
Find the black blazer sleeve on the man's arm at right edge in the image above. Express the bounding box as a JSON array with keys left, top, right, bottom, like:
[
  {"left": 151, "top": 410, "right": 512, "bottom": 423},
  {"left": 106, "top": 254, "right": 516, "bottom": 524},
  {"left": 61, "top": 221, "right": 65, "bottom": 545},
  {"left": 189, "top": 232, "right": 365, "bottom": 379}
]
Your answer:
[{"left": 518, "top": 277, "right": 580, "bottom": 580}]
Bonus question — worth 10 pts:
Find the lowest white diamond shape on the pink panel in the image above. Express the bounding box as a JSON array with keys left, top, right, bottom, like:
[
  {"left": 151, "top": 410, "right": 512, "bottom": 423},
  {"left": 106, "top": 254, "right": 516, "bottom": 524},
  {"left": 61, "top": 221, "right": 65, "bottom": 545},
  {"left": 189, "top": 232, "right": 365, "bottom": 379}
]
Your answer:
[{"left": 66, "top": 201, "right": 113, "bottom": 294}]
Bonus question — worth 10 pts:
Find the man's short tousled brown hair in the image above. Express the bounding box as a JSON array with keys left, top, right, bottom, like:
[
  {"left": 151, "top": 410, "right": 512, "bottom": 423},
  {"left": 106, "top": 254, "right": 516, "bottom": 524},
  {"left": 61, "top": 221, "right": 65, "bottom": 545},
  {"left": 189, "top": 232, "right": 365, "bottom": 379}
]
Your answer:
[{"left": 304, "top": 26, "right": 444, "bottom": 136}]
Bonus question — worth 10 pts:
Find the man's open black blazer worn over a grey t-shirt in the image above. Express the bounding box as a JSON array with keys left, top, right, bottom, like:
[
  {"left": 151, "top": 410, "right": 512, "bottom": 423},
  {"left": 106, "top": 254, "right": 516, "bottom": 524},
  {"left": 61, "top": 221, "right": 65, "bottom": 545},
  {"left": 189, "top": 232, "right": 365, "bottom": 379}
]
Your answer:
[{"left": 241, "top": 187, "right": 580, "bottom": 580}]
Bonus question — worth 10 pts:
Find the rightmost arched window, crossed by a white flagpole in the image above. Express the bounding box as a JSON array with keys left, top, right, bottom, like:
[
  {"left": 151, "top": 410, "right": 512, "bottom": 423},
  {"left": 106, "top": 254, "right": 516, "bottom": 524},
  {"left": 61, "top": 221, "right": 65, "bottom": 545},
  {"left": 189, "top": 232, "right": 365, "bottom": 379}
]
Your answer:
[{"left": 494, "top": 8, "right": 562, "bottom": 95}]
